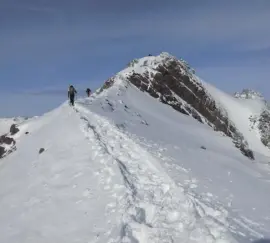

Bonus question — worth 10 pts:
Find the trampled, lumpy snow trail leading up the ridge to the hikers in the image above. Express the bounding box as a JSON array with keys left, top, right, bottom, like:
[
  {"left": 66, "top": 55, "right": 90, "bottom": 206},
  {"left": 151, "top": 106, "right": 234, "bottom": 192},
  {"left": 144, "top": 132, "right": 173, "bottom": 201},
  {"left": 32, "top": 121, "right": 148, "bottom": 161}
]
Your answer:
[{"left": 77, "top": 105, "right": 237, "bottom": 242}]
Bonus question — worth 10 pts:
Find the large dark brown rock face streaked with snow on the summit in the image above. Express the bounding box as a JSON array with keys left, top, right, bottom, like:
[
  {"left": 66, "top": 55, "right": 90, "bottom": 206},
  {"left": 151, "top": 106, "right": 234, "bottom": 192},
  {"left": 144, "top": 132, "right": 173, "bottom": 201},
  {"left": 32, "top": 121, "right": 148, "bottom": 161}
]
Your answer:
[{"left": 107, "top": 53, "right": 254, "bottom": 159}]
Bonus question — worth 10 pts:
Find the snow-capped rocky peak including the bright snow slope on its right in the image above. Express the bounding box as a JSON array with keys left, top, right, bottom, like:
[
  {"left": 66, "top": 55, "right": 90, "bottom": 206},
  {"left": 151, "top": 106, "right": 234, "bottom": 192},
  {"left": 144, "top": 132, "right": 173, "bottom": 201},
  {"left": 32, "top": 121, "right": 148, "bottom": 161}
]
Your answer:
[{"left": 98, "top": 53, "right": 270, "bottom": 159}]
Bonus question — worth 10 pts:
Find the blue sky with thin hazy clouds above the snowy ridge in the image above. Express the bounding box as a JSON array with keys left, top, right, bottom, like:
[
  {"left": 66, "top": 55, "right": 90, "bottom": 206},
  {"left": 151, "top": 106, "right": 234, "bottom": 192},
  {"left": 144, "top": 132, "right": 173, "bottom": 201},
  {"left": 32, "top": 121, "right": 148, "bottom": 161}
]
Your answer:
[{"left": 0, "top": 0, "right": 270, "bottom": 117}]
